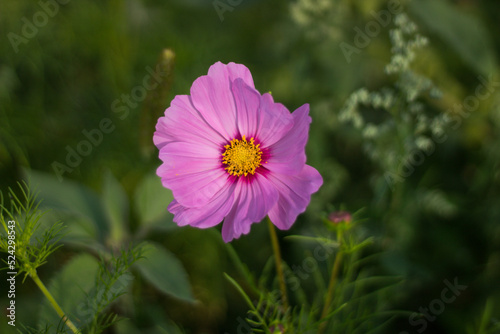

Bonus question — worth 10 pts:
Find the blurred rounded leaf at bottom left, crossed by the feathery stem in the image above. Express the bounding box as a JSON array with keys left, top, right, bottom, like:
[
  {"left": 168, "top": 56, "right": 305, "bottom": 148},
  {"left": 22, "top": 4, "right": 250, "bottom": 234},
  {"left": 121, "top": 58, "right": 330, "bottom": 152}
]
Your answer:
[{"left": 40, "top": 254, "right": 99, "bottom": 327}]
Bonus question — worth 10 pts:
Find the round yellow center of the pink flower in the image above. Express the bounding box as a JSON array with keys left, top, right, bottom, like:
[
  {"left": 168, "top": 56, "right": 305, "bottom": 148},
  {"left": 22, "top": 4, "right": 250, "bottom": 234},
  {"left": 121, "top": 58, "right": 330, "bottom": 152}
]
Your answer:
[{"left": 222, "top": 136, "right": 262, "bottom": 176}]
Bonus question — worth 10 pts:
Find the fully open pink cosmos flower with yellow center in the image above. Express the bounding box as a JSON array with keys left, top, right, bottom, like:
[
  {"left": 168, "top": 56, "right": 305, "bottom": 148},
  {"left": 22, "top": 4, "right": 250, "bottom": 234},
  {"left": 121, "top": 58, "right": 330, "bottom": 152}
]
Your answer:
[{"left": 153, "top": 62, "right": 323, "bottom": 242}]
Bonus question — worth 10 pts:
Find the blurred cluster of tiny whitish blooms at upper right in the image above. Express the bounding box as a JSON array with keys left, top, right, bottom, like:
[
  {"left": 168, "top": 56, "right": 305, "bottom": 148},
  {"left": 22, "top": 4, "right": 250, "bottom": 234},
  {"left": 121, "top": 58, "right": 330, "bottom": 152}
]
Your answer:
[{"left": 339, "top": 13, "right": 447, "bottom": 185}]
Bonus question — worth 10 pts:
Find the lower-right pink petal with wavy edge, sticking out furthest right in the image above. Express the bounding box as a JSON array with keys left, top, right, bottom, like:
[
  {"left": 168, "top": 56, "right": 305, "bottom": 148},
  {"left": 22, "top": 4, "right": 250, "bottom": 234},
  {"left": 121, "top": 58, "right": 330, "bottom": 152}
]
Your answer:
[{"left": 268, "top": 165, "right": 323, "bottom": 230}]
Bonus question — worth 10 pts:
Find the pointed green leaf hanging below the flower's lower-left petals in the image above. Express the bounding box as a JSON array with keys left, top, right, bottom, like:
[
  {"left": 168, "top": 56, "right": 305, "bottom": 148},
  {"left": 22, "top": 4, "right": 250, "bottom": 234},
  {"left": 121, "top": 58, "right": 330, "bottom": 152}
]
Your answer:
[{"left": 134, "top": 243, "right": 195, "bottom": 302}]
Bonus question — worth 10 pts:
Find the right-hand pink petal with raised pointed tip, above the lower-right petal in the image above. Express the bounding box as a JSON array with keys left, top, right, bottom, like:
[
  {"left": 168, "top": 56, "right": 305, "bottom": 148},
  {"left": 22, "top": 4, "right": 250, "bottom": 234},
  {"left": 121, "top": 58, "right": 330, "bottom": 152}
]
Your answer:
[{"left": 265, "top": 104, "right": 311, "bottom": 174}]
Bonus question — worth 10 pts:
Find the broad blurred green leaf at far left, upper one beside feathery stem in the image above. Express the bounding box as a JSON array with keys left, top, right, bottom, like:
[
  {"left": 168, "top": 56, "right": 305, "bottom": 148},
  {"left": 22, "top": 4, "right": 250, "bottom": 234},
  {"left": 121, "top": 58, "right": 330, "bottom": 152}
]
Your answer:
[{"left": 25, "top": 170, "right": 108, "bottom": 240}]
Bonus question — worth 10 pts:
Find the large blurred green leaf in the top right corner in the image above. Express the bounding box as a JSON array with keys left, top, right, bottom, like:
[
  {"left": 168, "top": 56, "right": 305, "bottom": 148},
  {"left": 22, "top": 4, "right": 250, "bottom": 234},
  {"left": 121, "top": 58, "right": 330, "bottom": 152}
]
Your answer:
[{"left": 409, "top": 0, "right": 496, "bottom": 75}]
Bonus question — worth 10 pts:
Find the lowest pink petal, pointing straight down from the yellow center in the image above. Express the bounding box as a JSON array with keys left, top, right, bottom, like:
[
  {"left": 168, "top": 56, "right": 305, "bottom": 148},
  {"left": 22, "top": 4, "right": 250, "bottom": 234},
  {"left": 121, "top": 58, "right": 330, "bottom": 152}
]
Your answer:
[{"left": 222, "top": 174, "right": 278, "bottom": 242}]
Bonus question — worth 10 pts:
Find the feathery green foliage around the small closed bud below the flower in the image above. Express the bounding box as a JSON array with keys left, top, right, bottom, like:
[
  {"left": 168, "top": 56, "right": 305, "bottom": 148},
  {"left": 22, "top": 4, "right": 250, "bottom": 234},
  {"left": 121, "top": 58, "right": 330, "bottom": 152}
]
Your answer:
[{"left": 225, "top": 213, "right": 404, "bottom": 333}]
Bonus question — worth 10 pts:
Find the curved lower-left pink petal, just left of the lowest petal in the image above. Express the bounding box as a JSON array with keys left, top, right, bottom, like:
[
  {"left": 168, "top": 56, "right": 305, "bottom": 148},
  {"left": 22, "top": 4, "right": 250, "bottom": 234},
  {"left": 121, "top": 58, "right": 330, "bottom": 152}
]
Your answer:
[{"left": 168, "top": 183, "right": 234, "bottom": 228}]
